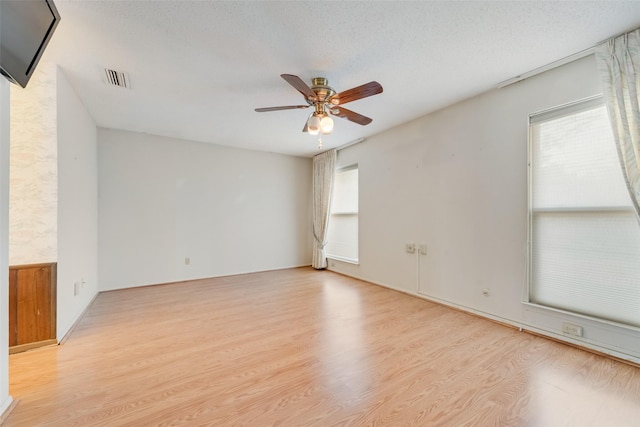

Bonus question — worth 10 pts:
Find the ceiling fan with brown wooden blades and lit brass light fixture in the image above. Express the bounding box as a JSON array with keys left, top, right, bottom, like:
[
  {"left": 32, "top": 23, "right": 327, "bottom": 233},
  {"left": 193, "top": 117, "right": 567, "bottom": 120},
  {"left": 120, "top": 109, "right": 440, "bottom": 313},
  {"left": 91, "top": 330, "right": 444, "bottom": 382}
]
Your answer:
[{"left": 256, "top": 74, "right": 382, "bottom": 135}]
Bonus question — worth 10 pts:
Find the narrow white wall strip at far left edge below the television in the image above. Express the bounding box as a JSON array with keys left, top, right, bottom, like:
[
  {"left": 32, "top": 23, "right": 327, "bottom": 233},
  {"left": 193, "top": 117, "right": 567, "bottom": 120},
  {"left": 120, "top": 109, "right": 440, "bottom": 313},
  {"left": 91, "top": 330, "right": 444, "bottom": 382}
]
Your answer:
[{"left": 0, "top": 77, "right": 13, "bottom": 416}]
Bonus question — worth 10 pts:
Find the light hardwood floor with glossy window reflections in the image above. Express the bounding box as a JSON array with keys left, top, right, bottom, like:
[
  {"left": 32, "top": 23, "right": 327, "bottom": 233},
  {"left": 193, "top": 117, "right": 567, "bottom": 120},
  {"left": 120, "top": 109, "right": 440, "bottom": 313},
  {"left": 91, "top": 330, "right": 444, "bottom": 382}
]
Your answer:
[{"left": 5, "top": 268, "right": 640, "bottom": 427}]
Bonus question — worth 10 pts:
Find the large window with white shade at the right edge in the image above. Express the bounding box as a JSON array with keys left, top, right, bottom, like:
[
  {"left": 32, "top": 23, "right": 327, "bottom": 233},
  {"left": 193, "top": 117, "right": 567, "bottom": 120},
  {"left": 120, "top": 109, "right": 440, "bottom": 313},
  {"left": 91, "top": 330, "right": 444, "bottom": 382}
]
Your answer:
[{"left": 529, "top": 98, "right": 640, "bottom": 327}]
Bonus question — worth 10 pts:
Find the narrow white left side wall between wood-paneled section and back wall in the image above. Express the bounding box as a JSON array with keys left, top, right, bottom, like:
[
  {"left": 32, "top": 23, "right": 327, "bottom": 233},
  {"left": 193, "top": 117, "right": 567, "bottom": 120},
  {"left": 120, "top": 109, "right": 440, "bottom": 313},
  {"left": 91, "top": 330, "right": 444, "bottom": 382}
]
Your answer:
[{"left": 56, "top": 68, "right": 98, "bottom": 340}]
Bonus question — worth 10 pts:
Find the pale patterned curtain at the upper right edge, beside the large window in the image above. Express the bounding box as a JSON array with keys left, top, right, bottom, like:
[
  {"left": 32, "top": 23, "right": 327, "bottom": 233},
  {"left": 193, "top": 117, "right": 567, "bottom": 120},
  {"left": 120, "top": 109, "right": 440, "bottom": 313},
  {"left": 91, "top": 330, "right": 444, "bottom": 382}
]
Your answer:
[{"left": 596, "top": 29, "right": 640, "bottom": 220}]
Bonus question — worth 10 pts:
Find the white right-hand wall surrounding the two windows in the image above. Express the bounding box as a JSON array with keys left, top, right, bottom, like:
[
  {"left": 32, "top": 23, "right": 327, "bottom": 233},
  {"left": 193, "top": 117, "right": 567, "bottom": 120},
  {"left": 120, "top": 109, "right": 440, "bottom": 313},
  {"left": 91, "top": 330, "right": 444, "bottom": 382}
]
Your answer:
[{"left": 330, "top": 57, "right": 640, "bottom": 361}]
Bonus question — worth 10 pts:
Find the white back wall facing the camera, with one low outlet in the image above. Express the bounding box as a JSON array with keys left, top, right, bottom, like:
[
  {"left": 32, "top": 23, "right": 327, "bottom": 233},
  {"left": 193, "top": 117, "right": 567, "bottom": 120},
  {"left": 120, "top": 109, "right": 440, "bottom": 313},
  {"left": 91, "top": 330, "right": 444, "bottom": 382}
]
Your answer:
[{"left": 98, "top": 128, "right": 311, "bottom": 290}]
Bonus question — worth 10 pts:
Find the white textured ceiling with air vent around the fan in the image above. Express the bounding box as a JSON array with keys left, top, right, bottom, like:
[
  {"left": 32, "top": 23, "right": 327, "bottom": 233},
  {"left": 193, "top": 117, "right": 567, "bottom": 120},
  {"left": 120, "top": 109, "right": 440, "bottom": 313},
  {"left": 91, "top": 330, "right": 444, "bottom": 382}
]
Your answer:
[{"left": 47, "top": 0, "right": 640, "bottom": 156}]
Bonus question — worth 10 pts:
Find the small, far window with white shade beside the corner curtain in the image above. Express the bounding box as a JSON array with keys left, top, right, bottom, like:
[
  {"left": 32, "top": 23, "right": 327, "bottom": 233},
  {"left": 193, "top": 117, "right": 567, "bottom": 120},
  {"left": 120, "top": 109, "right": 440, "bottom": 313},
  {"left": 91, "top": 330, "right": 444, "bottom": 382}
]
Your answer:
[{"left": 326, "top": 165, "right": 358, "bottom": 263}]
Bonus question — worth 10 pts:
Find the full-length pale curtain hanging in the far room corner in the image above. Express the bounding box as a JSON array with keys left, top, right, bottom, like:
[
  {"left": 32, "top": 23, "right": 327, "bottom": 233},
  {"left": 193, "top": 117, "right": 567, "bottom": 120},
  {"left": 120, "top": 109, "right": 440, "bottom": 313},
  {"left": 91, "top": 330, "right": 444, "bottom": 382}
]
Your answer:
[{"left": 311, "top": 149, "right": 336, "bottom": 270}]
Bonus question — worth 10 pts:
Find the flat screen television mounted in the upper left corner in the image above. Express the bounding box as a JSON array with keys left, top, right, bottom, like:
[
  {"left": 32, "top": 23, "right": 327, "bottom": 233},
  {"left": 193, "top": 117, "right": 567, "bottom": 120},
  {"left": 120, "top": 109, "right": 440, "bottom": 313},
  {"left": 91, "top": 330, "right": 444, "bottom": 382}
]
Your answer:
[{"left": 0, "top": 0, "right": 60, "bottom": 87}]
